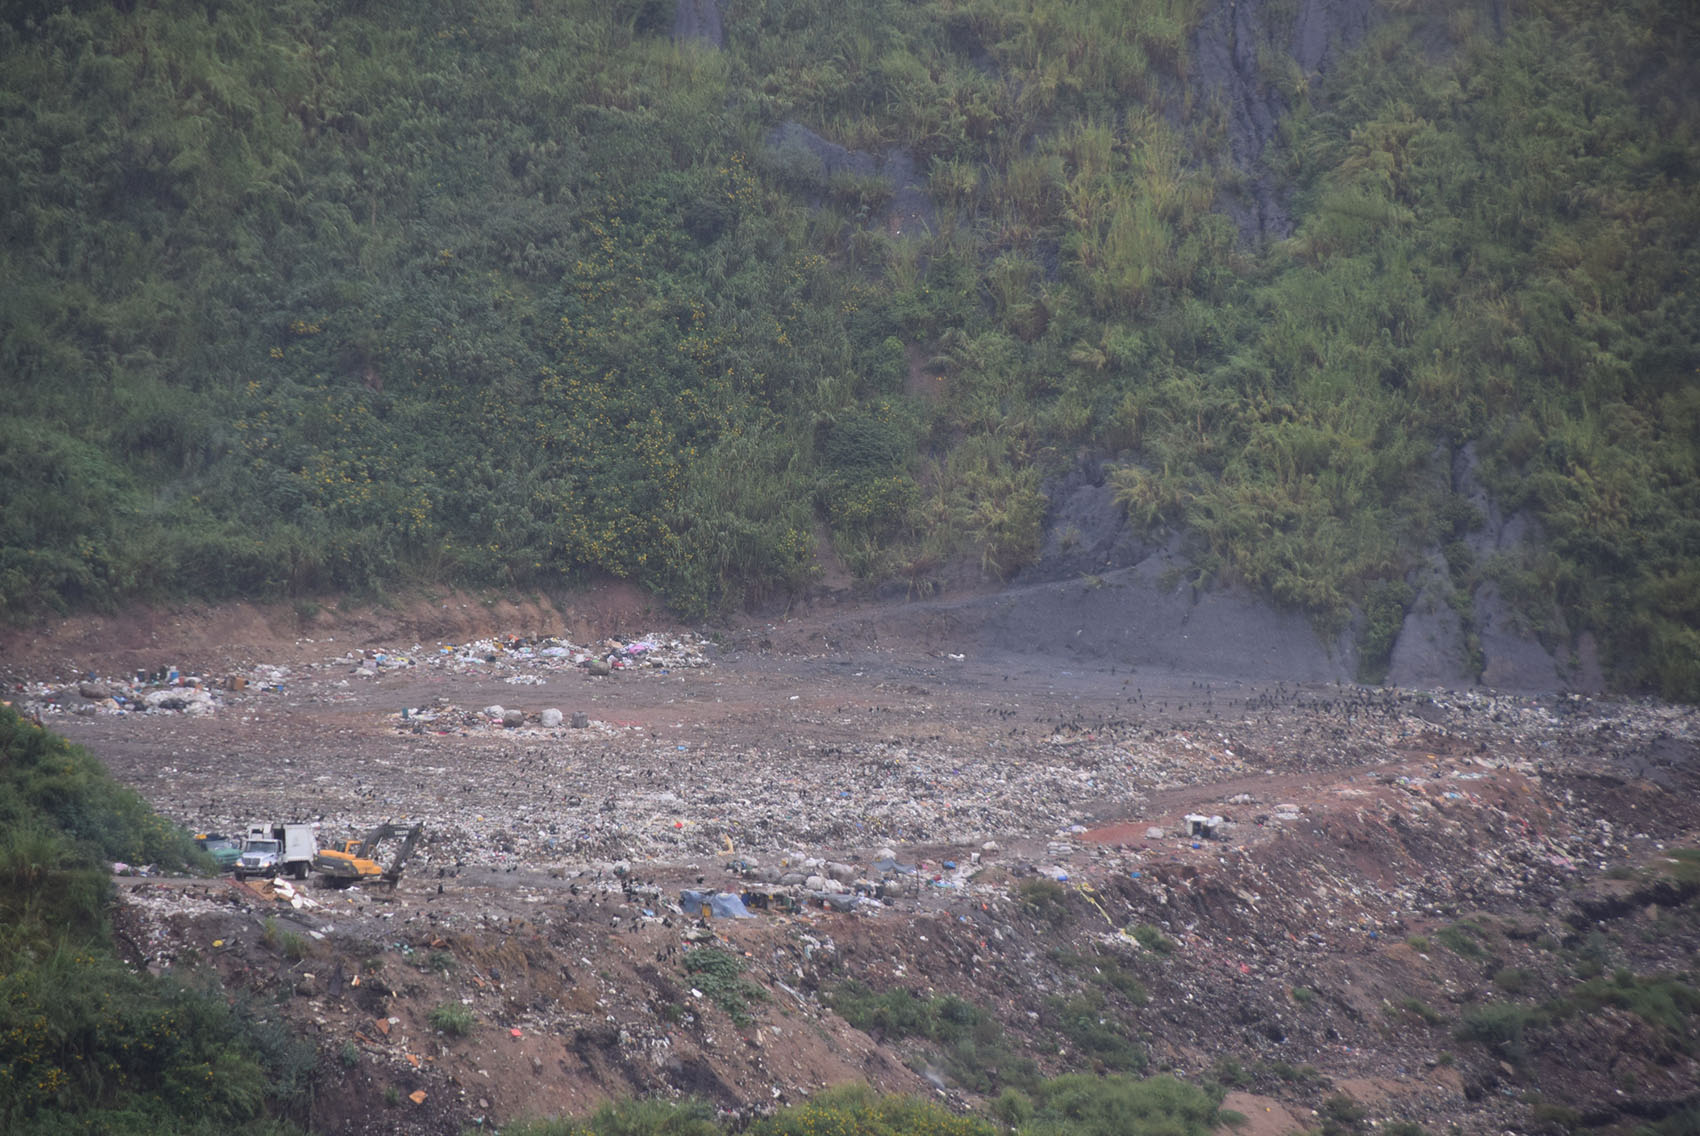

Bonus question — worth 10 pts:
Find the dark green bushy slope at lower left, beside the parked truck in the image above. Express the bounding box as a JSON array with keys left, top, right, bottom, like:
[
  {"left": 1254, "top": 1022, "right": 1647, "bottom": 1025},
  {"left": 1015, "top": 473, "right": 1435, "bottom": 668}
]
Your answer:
[{"left": 0, "top": 706, "right": 315, "bottom": 1134}]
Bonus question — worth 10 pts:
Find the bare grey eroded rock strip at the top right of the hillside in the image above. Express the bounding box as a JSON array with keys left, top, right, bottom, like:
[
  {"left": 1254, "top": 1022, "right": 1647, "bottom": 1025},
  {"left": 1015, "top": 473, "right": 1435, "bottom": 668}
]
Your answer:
[{"left": 1192, "top": 0, "right": 1380, "bottom": 243}]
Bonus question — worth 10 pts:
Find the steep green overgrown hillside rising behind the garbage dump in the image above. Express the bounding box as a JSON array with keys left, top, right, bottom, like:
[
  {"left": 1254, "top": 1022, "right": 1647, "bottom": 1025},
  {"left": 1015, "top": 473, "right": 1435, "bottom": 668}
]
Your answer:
[{"left": 0, "top": 0, "right": 1700, "bottom": 699}]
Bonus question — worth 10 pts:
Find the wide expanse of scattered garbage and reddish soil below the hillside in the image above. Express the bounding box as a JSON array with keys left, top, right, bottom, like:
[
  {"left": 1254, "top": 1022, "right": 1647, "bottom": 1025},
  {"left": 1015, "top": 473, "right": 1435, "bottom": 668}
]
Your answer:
[{"left": 16, "top": 612, "right": 1700, "bottom": 1133}]
